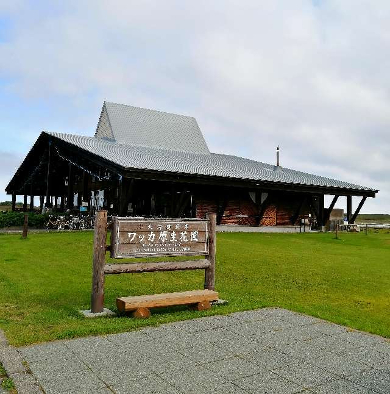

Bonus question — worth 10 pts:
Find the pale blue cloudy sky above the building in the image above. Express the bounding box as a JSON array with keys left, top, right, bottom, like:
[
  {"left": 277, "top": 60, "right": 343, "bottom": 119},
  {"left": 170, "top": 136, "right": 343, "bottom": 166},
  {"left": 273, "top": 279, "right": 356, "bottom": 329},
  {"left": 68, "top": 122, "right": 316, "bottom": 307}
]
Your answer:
[{"left": 0, "top": 0, "right": 390, "bottom": 213}]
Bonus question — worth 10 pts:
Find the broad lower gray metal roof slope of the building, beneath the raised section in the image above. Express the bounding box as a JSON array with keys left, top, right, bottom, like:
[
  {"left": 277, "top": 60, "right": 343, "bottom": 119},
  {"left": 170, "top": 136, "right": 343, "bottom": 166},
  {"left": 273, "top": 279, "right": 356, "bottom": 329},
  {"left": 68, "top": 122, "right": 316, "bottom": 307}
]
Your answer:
[{"left": 48, "top": 133, "right": 375, "bottom": 191}]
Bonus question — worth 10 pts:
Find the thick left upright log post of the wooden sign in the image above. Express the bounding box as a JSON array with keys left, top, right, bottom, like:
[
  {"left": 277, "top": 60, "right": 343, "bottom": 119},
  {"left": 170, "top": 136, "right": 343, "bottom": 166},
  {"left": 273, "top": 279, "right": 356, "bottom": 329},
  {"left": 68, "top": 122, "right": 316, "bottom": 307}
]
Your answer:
[{"left": 91, "top": 211, "right": 107, "bottom": 313}]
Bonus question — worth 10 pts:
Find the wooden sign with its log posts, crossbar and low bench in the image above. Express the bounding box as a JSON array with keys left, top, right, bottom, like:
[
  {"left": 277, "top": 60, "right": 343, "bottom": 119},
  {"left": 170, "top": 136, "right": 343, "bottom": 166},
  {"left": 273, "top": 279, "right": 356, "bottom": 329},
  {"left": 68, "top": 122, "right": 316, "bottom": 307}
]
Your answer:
[{"left": 91, "top": 211, "right": 218, "bottom": 318}]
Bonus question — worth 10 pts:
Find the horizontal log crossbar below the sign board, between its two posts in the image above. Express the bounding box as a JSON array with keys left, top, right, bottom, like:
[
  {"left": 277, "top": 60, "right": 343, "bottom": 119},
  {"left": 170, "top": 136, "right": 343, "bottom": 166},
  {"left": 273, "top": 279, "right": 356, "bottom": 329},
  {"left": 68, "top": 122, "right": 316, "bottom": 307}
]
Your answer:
[{"left": 104, "top": 259, "right": 210, "bottom": 275}]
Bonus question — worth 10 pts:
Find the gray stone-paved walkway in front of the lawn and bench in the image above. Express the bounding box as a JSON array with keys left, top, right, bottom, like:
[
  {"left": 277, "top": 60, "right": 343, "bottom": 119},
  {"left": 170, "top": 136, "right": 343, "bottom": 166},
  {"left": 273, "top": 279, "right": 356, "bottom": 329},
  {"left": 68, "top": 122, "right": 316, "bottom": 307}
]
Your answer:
[{"left": 19, "top": 308, "right": 390, "bottom": 394}]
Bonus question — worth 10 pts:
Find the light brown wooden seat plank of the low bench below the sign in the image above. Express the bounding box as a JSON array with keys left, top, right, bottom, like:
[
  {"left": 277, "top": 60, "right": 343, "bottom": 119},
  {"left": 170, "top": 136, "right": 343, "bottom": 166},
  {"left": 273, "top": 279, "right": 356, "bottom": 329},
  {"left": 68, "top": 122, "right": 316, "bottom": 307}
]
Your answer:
[{"left": 116, "top": 290, "right": 218, "bottom": 312}]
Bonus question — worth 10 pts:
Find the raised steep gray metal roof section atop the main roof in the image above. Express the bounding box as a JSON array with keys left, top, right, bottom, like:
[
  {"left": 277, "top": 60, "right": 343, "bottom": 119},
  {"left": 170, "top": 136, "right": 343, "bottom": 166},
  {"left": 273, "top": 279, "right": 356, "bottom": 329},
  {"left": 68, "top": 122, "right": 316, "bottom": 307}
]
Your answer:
[{"left": 95, "top": 102, "right": 210, "bottom": 154}]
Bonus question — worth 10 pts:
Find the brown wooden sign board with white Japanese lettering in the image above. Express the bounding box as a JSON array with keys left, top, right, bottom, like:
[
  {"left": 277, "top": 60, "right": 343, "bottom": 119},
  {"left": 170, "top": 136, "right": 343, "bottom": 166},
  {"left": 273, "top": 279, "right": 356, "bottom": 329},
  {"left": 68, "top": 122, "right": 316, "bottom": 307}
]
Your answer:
[{"left": 111, "top": 217, "right": 209, "bottom": 258}]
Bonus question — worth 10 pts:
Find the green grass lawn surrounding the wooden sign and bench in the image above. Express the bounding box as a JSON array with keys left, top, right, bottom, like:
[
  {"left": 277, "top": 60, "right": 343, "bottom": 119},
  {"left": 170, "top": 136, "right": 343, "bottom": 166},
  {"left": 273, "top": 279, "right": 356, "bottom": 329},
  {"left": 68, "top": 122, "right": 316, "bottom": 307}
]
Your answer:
[{"left": 0, "top": 231, "right": 390, "bottom": 346}]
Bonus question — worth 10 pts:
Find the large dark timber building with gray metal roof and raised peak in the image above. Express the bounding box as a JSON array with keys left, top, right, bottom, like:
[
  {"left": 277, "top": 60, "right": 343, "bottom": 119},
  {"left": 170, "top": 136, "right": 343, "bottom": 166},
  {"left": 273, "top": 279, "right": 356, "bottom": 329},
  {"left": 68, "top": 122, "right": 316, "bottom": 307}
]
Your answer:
[{"left": 6, "top": 102, "right": 378, "bottom": 225}]
